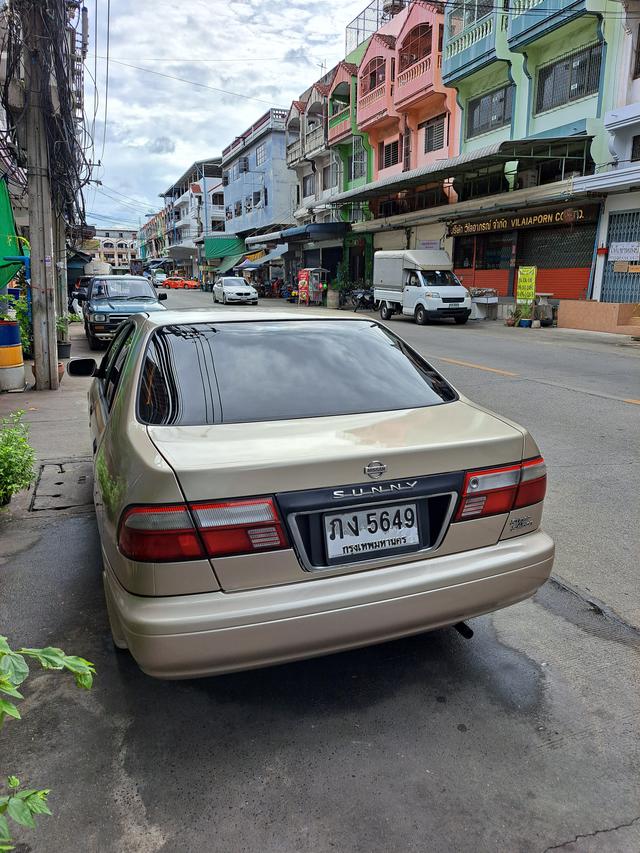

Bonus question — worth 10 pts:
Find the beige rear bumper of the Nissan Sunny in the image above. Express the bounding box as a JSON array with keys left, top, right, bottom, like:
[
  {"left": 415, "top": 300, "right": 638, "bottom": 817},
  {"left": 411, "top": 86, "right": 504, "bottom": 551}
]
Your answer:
[{"left": 103, "top": 530, "right": 554, "bottom": 678}]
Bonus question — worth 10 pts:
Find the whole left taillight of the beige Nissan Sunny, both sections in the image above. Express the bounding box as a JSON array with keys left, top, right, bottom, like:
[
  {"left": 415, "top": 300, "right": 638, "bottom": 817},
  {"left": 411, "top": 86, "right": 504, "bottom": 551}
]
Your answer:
[{"left": 118, "top": 498, "right": 287, "bottom": 563}]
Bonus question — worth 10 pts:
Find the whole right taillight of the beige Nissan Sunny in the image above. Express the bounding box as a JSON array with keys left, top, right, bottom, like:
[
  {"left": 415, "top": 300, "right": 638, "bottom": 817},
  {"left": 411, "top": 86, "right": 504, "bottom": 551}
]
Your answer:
[{"left": 456, "top": 456, "right": 547, "bottom": 521}]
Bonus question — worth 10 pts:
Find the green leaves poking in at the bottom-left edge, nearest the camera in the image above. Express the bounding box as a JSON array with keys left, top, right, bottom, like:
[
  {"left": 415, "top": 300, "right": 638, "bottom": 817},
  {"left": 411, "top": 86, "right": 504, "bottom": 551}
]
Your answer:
[{"left": 0, "top": 635, "right": 96, "bottom": 853}]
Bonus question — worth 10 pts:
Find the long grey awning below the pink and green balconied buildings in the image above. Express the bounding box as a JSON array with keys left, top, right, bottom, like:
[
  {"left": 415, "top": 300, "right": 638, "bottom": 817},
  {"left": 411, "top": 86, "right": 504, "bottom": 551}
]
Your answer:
[{"left": 327, "top": 135, "right": 593, "bottom": 204}]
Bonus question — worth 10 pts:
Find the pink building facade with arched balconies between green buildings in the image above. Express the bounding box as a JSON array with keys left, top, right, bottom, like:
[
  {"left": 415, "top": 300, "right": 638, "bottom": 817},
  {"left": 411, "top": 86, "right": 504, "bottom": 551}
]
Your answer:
[{"left": 357, "top": 3, "right": 460, "bottom": 180}]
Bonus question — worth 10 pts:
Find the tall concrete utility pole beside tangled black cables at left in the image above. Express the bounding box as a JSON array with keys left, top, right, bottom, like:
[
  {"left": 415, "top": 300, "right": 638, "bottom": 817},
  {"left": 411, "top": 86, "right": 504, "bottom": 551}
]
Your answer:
[{"left": 22, "top": 2, "right": 58, "bottom": 391}]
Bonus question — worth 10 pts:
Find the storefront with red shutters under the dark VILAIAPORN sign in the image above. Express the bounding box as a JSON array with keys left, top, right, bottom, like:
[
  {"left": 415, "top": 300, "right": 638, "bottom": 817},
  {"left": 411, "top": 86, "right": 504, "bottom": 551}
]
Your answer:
[{"left": 447, "top": 203, "right": 600, "bottom": 299}]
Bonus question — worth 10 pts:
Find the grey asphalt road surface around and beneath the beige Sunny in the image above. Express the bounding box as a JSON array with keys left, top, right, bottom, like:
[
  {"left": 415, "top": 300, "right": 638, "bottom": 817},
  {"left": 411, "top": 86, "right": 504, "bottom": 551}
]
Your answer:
[{"left": 0, "top": 292, "right": 640, "bottom": 853}]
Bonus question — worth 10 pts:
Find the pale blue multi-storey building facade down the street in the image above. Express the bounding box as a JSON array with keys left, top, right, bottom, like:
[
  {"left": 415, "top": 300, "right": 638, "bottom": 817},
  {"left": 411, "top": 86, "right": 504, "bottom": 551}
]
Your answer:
[{"left": 222, "top": 109, "right": 297, "bottom": 237}]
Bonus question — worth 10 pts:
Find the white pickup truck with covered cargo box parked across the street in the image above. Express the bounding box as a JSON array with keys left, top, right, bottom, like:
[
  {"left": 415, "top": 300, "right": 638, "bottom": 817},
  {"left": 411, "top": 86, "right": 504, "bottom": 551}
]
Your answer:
[{"left": 373, "top": 249, "right": 471, "bottom": 326}]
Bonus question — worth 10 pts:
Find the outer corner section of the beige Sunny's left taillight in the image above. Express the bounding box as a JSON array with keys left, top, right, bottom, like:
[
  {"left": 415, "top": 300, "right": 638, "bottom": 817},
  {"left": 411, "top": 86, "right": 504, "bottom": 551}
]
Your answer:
[{"left": 118, "top": 506, "right": 205, "bottom": 563}]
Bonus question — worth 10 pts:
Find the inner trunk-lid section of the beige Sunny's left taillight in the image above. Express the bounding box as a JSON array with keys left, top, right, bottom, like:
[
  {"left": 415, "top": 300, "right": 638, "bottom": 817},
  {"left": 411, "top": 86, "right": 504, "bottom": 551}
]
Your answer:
[{"left": 191, "top": 498, "right": 287, "bottom": 557}]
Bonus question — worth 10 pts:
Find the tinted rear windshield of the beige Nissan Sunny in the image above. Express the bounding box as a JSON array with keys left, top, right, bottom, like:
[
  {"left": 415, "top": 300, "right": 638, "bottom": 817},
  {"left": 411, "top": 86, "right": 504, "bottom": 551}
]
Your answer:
[{"left": 138, "top": 320, "right": 457, "bottom": 426}]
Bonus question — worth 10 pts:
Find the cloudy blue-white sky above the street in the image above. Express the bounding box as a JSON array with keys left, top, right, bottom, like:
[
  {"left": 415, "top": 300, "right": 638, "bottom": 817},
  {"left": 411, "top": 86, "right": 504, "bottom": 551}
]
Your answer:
[{"left": 84, "top": 0, "right": 367, "bottom": 228}]
